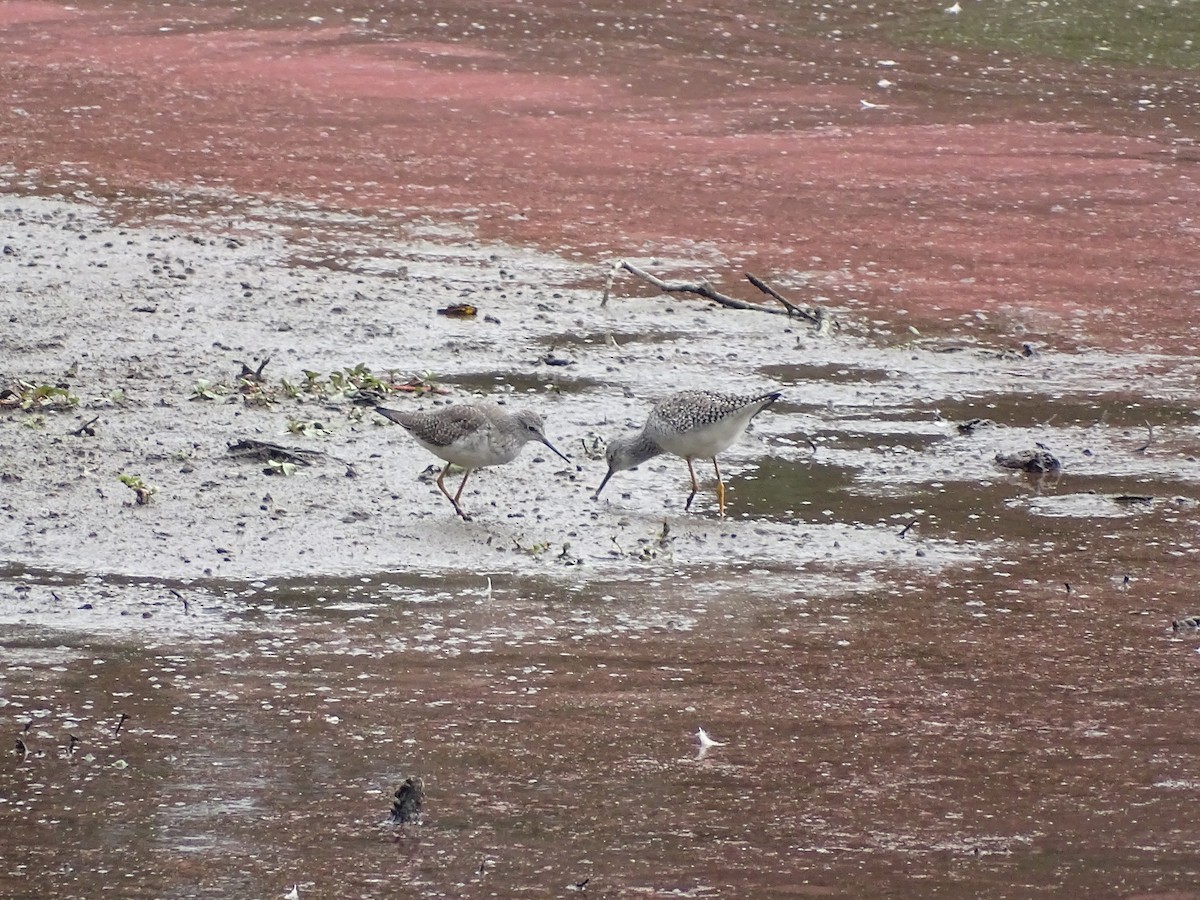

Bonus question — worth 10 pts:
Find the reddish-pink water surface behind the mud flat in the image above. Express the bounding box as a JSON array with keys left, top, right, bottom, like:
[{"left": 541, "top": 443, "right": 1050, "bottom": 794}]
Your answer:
[{"left": 0, "top": 2, "right": 1200, "bottom": 348}]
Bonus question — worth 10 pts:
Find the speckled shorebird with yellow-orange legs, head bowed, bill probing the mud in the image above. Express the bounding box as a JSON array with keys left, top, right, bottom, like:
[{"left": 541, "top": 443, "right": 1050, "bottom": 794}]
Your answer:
[{"left": 595, "top": 391, "right": 782, "bottom": 516}]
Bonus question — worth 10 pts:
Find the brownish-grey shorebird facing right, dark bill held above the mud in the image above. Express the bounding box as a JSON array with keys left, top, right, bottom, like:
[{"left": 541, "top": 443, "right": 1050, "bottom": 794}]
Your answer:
[{"left": 376, "top": 402, "right": 570, "bottom": 522}]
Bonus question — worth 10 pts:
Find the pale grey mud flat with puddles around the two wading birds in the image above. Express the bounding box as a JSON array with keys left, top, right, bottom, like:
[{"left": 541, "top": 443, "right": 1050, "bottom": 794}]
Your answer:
[{"left": 9, "top": 199, "right": 1200, "bottom": 592}]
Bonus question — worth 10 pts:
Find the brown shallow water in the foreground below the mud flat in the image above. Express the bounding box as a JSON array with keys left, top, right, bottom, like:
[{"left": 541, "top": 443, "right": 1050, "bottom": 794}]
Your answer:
[{"left": 5, "top": 565, "right": 1196, "bottom": 896}]
